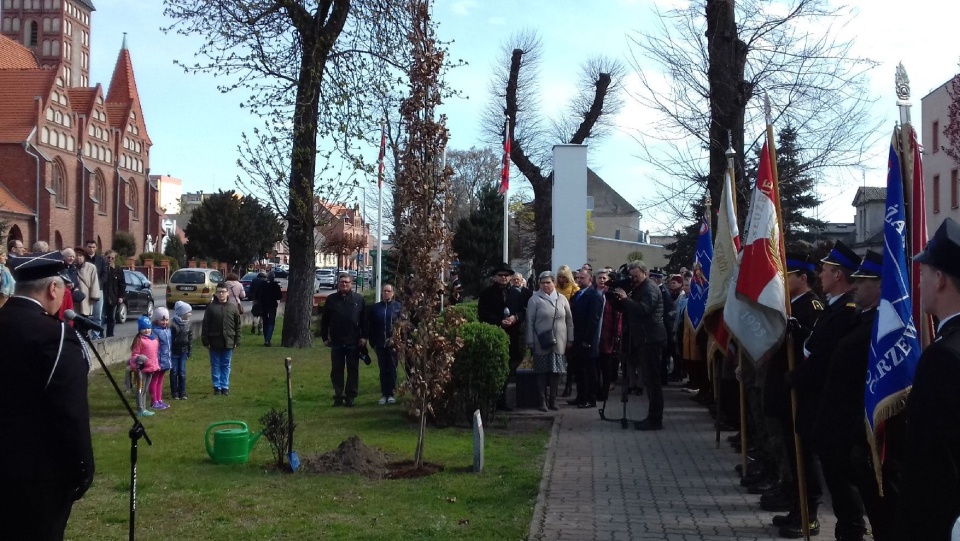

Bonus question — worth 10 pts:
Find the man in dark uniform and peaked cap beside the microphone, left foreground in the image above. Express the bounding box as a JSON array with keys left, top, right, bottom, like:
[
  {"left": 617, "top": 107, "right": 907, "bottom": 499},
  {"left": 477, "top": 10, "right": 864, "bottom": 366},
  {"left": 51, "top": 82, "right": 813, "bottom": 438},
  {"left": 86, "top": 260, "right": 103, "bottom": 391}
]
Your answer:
[{"left": 0, "top": 252, "right": 94, "bottom": 540}]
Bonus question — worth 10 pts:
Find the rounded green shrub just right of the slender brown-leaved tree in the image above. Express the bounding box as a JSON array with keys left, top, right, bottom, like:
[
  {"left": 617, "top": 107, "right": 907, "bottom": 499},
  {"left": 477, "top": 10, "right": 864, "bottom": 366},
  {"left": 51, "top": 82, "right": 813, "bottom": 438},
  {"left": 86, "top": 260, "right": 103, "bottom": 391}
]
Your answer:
[{"left": 435, "top": 321, "right": 510, "bottom": 424}]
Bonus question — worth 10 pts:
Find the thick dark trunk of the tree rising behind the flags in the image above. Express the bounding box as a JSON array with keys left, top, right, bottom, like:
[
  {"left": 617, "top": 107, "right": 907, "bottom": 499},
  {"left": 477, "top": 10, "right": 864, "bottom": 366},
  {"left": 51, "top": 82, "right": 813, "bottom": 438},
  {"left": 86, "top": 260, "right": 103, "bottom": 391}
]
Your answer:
[{"left": 706, "top": 0, "right": 753, "bottom": 226}]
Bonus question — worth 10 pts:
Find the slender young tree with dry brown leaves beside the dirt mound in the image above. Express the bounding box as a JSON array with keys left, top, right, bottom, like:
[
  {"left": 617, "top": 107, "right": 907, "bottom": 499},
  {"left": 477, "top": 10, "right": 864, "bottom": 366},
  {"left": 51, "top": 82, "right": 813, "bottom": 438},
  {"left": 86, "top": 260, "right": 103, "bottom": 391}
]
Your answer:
[{"left": 394, "top": 0, "right": 462, "bottom": 468}]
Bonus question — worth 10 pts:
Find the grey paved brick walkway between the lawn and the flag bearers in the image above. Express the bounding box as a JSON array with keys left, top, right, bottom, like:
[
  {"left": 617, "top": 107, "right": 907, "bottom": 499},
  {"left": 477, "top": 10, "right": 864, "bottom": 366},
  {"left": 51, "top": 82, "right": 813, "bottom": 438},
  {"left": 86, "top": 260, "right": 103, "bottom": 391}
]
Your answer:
[{"left": 529, "top": 384, "right": 856, "bottom": 541}]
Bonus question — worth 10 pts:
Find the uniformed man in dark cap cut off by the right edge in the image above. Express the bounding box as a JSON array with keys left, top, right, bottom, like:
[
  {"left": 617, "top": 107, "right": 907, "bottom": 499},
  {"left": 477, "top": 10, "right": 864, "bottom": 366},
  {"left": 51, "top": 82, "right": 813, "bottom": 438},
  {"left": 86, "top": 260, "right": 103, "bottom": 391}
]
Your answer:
[{"left": 895, "top": 218, "right": 960, "bottom": 541}]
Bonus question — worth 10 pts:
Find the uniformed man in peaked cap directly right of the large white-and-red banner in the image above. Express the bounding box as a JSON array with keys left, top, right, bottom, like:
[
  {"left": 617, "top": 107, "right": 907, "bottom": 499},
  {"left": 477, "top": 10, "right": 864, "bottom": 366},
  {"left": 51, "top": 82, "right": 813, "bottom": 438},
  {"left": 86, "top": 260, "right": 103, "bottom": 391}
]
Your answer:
[{"left": 761, "top": 253, "right": 823, "bottom": 528}]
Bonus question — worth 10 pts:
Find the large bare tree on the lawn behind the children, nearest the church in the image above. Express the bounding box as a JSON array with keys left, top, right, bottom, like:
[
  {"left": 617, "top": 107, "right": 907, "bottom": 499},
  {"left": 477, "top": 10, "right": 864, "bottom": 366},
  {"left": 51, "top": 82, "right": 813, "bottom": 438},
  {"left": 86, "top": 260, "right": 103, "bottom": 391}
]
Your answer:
[{"left": 164, "top": 0, "right": 409, "bottom": 347}]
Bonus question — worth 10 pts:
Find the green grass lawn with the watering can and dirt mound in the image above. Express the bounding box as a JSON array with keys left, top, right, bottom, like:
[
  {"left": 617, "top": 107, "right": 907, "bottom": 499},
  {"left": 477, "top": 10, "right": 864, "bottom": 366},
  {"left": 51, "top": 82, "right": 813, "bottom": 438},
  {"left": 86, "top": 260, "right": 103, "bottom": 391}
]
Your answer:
[{"left": 66, "top": 318, "right": 549, "bottom": 540}]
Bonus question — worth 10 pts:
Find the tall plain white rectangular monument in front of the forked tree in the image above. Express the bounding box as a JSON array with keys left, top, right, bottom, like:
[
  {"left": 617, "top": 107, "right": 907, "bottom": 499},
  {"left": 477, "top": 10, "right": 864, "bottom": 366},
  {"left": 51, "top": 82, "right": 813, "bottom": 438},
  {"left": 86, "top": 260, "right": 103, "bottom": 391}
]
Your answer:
[{"left": 551, "top": 145, "right": 587, "bottom": 271}]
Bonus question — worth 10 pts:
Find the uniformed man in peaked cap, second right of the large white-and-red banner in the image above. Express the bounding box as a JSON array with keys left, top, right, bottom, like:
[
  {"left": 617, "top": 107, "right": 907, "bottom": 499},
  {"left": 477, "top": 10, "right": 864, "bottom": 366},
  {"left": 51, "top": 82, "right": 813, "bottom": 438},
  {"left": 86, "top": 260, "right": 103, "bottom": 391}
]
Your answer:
[{"left": 781, "top": 241, "right": 866, "bottom": 540}]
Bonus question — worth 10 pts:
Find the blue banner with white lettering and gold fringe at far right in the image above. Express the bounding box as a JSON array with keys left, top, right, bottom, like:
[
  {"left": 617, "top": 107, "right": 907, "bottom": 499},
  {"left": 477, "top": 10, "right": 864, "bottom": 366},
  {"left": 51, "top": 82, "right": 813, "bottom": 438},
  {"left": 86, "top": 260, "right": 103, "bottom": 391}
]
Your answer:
[{"left": 864, "top": 145, "right": 920, "bottom": 431}]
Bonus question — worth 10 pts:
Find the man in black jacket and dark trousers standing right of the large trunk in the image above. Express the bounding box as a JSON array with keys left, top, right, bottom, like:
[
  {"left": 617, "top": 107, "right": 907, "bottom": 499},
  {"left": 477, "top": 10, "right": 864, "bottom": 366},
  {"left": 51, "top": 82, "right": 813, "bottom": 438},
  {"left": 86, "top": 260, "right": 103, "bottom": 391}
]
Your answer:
[{"left": 320, "top": 272, "right": 367, "bottom": 408}]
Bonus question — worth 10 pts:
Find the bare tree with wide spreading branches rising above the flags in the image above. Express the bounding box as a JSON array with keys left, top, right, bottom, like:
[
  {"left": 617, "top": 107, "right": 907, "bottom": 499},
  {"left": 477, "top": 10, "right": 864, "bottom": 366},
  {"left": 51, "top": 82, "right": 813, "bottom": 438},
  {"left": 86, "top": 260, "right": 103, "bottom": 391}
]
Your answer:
[{"left": 631, "top": 0, "right": 879, "bottom": 227}]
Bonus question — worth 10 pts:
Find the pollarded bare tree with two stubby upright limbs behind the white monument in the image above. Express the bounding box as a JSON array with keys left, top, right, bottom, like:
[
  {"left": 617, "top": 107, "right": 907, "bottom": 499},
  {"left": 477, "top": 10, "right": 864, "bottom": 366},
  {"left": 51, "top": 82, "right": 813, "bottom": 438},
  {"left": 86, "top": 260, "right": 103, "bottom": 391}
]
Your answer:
[{"left": 484, "top": 31, "right": 625, "bottom": 272}]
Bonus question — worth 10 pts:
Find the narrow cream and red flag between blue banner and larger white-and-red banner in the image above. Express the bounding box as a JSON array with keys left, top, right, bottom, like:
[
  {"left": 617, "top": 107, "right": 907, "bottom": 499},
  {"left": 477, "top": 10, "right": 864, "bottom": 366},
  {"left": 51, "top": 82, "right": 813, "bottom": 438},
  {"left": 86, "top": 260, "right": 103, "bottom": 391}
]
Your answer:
[{"left": 703, "top": 172, "right": 740, "bottom": 352}]
